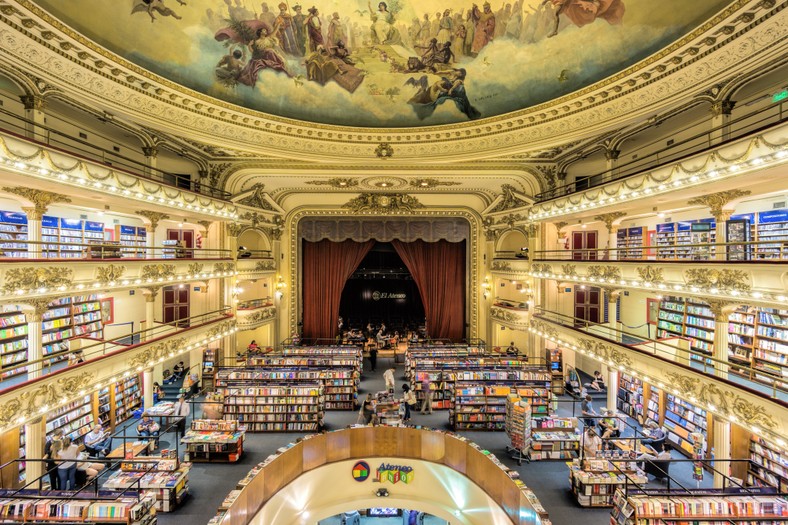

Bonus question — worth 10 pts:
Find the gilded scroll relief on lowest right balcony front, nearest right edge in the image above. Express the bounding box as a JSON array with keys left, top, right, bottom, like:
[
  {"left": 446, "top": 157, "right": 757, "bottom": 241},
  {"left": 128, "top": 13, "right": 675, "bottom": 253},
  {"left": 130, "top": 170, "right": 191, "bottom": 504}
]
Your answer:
[{"left": 663, "top": 370, "right": 779, "bottom": 430}]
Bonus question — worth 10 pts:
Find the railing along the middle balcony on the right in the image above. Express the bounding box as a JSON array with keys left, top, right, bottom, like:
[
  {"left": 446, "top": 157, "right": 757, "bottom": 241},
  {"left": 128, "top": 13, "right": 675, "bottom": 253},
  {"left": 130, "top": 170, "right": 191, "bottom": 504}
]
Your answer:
[{"left": 495, "top": 240, "right": 788, "bottom": 264}]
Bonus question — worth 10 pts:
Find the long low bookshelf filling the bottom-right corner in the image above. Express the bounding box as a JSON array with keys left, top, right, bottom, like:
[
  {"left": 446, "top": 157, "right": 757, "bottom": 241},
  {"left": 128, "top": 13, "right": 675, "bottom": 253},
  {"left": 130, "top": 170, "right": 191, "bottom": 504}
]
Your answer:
[{"left": 610, "top": 489, "right": 788, "bottom": 525}]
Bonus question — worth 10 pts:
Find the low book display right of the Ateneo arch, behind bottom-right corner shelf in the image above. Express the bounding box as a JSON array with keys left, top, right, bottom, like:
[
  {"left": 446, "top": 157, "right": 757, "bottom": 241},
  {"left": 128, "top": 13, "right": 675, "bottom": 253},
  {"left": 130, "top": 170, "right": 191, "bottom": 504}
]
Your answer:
[{"left": 569, "top": 450, "right": 648, "bottom": 507}]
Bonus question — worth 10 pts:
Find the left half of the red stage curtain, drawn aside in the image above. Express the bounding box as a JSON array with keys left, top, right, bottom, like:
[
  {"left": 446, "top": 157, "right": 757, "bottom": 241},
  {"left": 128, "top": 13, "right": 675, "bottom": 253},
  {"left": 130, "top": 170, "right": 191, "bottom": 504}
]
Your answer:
[{"left": 302, "top": 240, "right": 375, "bottom": 340}]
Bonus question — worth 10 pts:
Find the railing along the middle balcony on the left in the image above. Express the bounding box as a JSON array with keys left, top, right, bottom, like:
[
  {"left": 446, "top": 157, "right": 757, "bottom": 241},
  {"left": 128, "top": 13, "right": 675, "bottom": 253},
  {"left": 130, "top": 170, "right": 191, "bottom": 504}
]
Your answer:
[{"left": 0, "top": 239, "right": 233, "bottom": 262}]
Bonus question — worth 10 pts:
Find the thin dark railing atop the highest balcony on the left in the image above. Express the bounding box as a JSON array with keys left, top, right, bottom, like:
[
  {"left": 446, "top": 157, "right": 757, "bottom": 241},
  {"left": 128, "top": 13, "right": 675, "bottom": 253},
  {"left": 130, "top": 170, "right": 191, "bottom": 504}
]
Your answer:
[{"left": 0, "top": 99, "right": 230, "bottom": 200}]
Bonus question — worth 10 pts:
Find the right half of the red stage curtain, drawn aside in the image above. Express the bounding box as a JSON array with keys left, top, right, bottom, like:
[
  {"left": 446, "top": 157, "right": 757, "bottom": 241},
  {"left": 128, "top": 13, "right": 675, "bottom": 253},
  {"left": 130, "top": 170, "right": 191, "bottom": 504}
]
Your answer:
[{"left": 391, "top": 239, "right": 465, "bottom": 342}]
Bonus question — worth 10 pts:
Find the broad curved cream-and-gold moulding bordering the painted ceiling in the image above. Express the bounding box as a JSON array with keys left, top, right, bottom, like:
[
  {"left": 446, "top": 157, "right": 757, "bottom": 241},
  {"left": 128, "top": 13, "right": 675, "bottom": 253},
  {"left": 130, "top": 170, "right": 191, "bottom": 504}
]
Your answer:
[{"left": 2, "top": 0, "right": 785, "bottom": 158}]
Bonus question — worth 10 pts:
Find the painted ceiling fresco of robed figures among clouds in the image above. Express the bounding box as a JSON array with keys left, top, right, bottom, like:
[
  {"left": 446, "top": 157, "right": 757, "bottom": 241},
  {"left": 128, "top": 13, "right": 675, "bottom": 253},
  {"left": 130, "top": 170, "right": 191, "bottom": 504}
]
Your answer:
[{"left": 34, "top": 0, "right": 729, "bottom": 128}]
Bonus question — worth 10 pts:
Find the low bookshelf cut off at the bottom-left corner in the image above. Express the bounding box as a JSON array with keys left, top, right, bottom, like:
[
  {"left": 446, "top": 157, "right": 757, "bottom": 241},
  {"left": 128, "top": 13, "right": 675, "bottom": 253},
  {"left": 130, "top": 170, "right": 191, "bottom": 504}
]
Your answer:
[{"left": 0, "top": 491, "right": 156, "bottom": 525}]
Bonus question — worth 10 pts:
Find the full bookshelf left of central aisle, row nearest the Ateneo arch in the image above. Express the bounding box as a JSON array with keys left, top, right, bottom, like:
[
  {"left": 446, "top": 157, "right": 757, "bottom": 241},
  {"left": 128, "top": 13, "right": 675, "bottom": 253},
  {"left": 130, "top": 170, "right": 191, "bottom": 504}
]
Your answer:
[{"left": 216, "top": 369, "right": 324, "bottom": 432}]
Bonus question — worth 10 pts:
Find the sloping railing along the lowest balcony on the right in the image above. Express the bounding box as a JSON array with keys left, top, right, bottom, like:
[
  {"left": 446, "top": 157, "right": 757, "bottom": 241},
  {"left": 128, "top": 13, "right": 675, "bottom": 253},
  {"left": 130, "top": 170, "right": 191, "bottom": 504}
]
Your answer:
[{"left": 534, "top": 308, "right": 788, "bottom": 403}]
